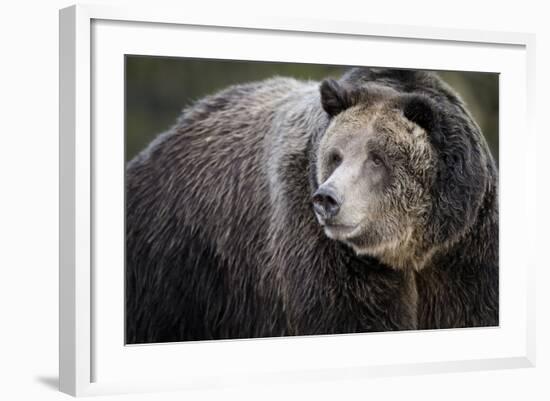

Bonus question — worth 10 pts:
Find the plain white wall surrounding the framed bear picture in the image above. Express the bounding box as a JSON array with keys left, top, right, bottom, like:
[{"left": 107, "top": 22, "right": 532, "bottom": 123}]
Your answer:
[{"left": 0, "top": 0, "right": 550, "bottom": 400}]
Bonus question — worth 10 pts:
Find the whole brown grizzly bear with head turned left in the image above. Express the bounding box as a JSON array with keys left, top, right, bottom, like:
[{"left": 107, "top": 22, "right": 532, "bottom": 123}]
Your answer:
[{"left": 126, "top": 68, "right": 498, "bottom": 343}]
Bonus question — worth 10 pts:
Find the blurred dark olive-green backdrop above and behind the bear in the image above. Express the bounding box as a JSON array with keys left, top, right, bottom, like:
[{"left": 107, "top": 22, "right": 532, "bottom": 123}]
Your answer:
[{"left": 125, "top": 56, "right": 498, "bottom": 163}]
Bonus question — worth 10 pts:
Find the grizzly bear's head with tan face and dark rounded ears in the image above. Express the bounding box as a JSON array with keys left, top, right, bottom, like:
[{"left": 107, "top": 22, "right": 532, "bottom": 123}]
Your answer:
[{"left": 312, "top": 71, "right": 492, "bottom": 269}]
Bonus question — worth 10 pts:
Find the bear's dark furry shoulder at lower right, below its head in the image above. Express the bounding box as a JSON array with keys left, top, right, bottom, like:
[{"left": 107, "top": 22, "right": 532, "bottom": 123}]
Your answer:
[{"left": 415, "top": 180, "right": 499, "bottom": 329}]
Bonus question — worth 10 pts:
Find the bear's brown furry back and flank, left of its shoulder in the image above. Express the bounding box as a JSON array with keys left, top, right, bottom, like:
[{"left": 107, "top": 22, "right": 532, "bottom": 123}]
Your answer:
[{"left": 126, "top": 78, "right": 324, "bottom": 343}]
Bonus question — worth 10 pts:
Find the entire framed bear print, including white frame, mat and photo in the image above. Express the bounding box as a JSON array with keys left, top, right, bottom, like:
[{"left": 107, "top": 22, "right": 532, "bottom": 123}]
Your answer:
[{"left": 60, "top": 6, "right": 535, "bottom": 395}]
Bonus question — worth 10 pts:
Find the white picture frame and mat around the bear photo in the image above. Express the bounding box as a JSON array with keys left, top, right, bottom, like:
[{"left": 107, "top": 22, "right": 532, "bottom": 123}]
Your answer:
[{"left": 59, "top": 5, "right": 535, "bottom": 396}]
